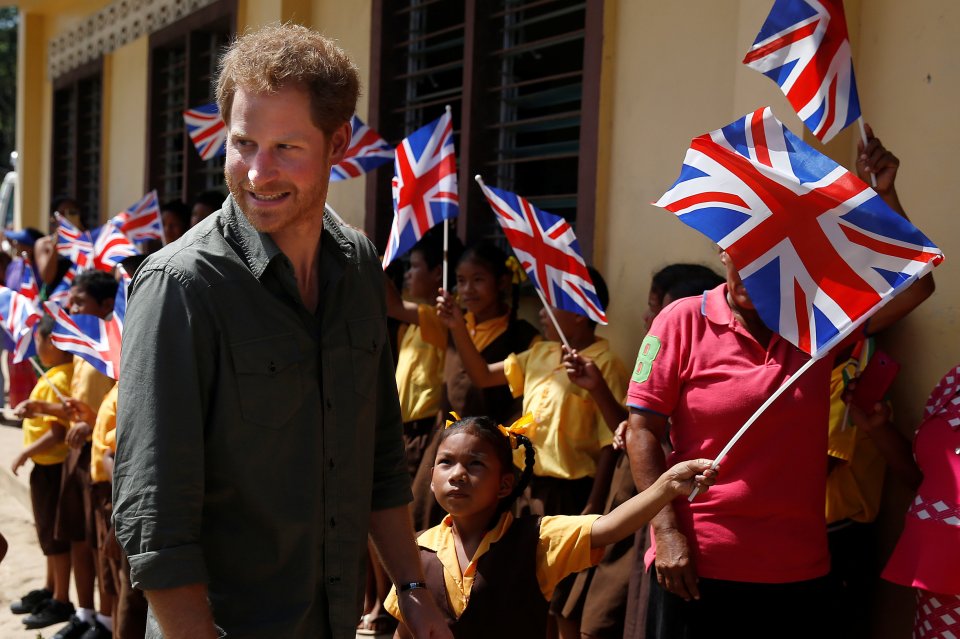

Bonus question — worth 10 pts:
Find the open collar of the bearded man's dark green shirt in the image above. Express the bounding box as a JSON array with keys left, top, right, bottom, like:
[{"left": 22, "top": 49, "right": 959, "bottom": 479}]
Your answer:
[{"left": 220, "top": 195, "right": 357, "bottom": 279}]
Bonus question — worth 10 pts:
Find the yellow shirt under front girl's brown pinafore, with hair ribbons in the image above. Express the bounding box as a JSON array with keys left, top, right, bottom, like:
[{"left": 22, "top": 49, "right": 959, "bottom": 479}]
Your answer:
[{"left": 383, "top": 513, "right": 606, "bottom": 619}]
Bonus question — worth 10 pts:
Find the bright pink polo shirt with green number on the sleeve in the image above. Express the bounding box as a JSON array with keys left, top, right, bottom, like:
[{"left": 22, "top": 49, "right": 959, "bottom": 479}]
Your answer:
[{"left": 627, "top": 284, "right": 832, "bottom": 583}]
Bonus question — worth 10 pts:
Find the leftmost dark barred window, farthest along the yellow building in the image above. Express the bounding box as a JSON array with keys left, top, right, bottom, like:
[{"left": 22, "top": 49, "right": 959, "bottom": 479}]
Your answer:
[{"left": 50, "top": 61, "right": 103, "bottom": 226}]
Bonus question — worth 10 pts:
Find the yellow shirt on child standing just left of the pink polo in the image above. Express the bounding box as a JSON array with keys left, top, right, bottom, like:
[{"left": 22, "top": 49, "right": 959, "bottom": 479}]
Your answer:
[{"left": 504, "top": 338, "right": 627, "bottom": 479}]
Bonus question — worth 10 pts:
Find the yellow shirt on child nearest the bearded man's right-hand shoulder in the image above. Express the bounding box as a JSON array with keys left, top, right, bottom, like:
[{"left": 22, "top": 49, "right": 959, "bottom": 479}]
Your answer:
[{"left": 397, "top": 304, "right": 447, "bottom": 422}]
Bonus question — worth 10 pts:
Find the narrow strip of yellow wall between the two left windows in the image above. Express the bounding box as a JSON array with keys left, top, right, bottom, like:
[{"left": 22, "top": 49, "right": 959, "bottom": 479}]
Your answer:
[{"left": 100, "top": 36, "right": 150, "bottom": 219}]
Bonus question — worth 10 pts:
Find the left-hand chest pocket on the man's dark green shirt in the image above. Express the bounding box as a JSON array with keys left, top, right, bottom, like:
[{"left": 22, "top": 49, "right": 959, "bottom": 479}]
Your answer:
[{"left": 230, "top": 335, "right": 304, "bottom": 429}]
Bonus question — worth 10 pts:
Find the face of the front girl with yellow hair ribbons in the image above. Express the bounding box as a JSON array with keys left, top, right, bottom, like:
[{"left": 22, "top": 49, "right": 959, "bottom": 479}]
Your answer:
[{"left": 430, "top": 432, "right": 514, "bottom": 522}]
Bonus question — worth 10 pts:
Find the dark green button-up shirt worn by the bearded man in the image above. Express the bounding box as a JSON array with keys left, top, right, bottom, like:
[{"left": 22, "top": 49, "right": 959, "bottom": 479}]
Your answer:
[{"left": 113, "top": 197, "right": 411, "bottom": 639}]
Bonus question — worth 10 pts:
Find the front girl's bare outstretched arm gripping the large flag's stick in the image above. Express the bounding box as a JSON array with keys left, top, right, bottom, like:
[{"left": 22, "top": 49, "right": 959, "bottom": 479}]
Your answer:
[{"left": 590, "top": 459, "right": 717, "bottom": 548}]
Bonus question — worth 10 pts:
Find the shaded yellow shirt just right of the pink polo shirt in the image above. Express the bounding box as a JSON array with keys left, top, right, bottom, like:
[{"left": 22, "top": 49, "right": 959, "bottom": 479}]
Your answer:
[{"left": 826, "top": 339, "right": 886, "bottom": 524}]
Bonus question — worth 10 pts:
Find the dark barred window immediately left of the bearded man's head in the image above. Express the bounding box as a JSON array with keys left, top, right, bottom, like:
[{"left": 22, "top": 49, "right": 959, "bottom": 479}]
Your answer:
[{"left": 147, "top": 0, "right": 236, "bottom": 202}]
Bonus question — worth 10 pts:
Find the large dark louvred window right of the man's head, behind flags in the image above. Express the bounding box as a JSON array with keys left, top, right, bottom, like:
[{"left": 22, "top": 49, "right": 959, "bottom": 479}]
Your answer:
[{"left": 367, "top": 0, "right": 603, "bottom": 259}]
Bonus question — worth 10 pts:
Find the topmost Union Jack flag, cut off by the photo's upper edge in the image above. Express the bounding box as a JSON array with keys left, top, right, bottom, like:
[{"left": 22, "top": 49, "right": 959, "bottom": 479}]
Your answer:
[{"left": 743, "top": 0, "right": 860, "bottom": 142}]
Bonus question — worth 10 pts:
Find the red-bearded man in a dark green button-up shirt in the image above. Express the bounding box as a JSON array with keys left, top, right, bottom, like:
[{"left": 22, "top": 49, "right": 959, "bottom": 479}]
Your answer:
[{"left": 114, "top": 24, "right": 449, "bottom": 639}]
